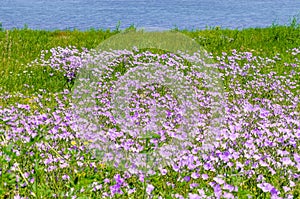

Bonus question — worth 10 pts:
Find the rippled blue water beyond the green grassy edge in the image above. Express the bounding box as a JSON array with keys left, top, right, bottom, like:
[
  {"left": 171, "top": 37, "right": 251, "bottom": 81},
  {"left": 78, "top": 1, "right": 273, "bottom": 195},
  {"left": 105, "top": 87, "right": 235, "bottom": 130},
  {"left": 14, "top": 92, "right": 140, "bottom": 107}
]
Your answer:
[{"left": 0, "top": 0, "right": 300, "bottom": 30}]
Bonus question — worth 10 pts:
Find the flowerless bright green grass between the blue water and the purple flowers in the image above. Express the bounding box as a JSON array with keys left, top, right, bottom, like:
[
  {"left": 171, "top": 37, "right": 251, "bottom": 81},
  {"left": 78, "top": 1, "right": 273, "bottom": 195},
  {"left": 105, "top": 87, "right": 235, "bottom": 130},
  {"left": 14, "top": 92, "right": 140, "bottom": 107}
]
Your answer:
[{"left": 0, "top": 24, "right": 300, "bottom": 97}]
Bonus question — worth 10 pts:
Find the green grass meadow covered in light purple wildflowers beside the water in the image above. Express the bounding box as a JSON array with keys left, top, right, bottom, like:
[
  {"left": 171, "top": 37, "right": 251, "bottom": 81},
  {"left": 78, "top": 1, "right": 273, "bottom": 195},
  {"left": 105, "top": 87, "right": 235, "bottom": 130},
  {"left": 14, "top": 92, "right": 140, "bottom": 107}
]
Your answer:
[{"left": 0, "top": 21, "right": 300, "bottom": 199}]
